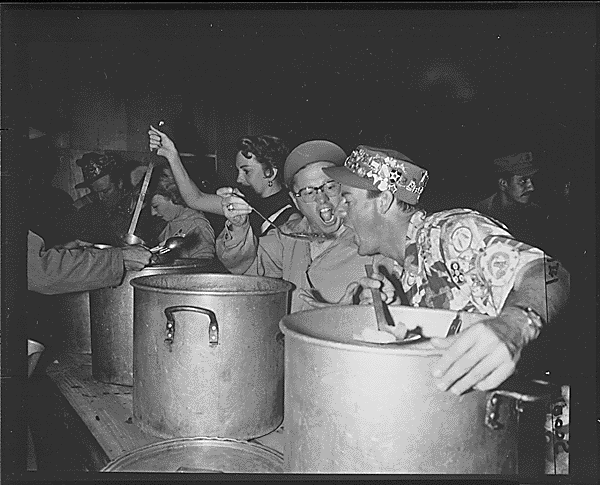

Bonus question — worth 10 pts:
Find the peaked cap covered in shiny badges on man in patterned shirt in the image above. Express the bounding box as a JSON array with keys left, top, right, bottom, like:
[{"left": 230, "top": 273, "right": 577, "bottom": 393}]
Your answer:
[{"left": 323, "top": 145, "right": 429, "bottom": 205}]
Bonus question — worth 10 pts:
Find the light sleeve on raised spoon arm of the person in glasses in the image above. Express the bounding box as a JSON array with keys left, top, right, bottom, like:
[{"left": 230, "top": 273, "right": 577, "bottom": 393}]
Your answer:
[{"left": 216, "top": 219, "right": 283, "bottom": 278}]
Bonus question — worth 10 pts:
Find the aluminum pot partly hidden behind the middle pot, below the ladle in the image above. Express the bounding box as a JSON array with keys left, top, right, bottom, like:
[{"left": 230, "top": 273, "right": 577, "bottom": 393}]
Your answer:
[{"left": 90, "top": 259, "right": 225, "bottom": 386}]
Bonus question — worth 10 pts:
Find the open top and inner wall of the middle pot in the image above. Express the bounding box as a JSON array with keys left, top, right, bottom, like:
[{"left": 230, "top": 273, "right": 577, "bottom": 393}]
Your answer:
[{"left": 131, "top": 273, "right": 293, "bottom": 295}]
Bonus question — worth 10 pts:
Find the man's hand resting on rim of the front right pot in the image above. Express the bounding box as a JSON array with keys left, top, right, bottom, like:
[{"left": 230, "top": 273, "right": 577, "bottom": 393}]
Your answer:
[{"left": 431, "top": 318, "right": 520, "bottom": 395}]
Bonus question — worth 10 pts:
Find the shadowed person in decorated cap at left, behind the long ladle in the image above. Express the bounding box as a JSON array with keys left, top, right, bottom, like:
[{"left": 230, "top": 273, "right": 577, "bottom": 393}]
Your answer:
[{"left": 70, "top": 153, "right": 157, "bottom": 246}]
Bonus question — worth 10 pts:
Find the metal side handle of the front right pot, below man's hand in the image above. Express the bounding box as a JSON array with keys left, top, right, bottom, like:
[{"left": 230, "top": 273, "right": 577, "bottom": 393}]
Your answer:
[{"left": 485, "top": 377, "right": 560, "bottom": 430}]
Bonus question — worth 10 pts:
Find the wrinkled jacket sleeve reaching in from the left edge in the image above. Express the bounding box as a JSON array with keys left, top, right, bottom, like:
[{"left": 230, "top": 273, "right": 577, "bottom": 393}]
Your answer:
[{"left": 27, "top": 231, "right": 125, "bottom": 295}]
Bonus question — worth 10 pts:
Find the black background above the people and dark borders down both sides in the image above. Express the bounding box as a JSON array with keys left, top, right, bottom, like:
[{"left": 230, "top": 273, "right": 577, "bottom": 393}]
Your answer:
[{"left": 1, "top": 3, "right": 597, "bottom": 483}]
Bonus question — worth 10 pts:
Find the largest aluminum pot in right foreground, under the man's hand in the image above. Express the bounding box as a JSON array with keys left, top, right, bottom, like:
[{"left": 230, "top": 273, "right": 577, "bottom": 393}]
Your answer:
[{"left": 280, "top": 306, "right": 543, "bottom": 474}]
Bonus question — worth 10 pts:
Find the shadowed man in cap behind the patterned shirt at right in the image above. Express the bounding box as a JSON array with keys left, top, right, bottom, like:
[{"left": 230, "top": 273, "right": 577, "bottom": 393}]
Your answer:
[{"left": 473, "top": 152, "right": 552, "bottom": 250}]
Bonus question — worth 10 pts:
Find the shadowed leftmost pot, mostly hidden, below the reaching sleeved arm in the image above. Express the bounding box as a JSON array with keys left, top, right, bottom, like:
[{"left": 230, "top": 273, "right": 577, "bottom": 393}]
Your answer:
[{"left": 53, "top": 291, "right": 92, "bottom": 354}]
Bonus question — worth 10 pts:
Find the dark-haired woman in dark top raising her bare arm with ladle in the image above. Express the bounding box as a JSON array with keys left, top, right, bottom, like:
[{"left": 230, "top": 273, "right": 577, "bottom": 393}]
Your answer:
[{"left": 148, "top": 126, "right": 295, "bottom": 237}]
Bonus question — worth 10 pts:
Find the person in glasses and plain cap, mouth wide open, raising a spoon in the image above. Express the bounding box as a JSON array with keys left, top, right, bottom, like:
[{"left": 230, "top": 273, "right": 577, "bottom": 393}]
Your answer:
[{"left": 216, "top": 140, "right": 393, "bottom": 312}]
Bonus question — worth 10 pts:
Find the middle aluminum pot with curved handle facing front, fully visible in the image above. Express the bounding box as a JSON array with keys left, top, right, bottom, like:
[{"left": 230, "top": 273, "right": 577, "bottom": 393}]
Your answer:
[{"left": 131, "top": 274, "right": 293, "bottom": 440}]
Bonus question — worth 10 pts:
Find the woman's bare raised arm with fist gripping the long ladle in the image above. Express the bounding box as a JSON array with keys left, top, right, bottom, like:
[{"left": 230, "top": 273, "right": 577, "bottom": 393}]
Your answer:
[{"left": 148, "top": 125, "right": 223, "bottom": 216}]
